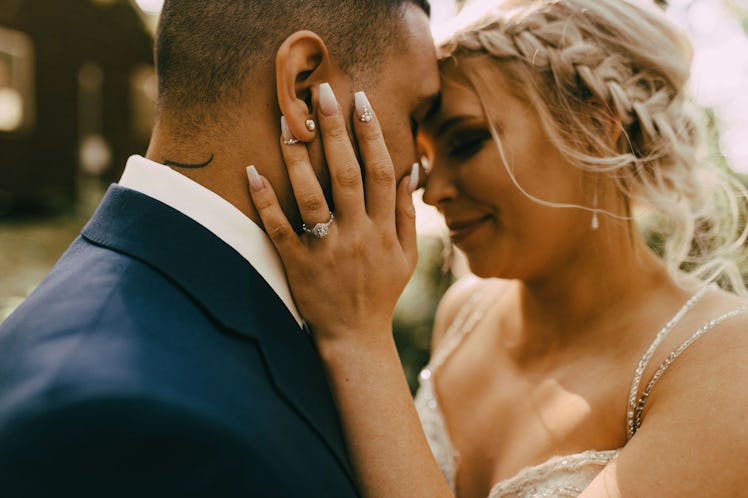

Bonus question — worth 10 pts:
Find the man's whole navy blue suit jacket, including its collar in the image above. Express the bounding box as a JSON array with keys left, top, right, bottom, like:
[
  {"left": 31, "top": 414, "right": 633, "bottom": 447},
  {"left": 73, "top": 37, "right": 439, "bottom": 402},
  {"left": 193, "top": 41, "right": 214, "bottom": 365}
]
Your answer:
[{"left": 0, "top": 186, "right": 358, "bottom": 498}]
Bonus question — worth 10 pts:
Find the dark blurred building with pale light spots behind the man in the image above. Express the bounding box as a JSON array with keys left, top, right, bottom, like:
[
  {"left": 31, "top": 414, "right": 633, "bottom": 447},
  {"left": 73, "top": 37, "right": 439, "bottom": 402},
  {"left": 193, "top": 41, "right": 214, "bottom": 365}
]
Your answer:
[{"left": 0, "top": 0, "right": 156, "bottom": 214}]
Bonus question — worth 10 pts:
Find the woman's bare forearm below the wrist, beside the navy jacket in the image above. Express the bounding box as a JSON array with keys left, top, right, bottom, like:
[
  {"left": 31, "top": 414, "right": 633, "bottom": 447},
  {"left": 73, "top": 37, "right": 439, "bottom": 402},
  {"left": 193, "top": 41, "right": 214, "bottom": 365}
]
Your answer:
[{"left": 318, "top": 331, "right": 453, "bottom": 498}]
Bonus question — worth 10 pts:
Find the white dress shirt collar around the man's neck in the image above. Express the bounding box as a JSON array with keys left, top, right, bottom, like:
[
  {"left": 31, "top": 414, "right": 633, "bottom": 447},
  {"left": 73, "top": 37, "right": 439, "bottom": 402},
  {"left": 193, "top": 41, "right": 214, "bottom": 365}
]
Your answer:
[{"left": 119, "top": 156, "right": 303, "bottom": 327}]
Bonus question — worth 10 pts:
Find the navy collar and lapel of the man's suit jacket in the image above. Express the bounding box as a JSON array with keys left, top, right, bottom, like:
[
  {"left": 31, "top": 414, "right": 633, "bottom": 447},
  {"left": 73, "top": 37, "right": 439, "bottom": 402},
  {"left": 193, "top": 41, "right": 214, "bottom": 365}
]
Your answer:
[{"left": 82, "top": 185, "right": 355, "bottom": 482}]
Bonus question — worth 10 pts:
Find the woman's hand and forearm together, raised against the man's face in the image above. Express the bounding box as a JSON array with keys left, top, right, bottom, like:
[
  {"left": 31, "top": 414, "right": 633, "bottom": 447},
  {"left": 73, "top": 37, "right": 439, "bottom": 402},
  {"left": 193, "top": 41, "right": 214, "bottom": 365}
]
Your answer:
[{"left": 247, "top": 86, "right": 453, "bottom": 498}]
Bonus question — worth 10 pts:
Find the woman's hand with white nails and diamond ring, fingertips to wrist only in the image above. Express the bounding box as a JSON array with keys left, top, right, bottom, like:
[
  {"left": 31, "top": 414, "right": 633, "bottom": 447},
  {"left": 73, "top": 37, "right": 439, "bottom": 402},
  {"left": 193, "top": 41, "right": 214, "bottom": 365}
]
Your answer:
[{"left": 248, "top": 85, "right": 418, "bottom": 344}]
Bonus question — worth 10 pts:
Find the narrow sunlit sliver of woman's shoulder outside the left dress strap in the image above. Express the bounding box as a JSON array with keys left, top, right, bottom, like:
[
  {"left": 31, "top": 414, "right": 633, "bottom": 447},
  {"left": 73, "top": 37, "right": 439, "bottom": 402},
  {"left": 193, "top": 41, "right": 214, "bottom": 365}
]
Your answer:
[{"left": 431, "top": 274, "right": 511, "bottom": 353}]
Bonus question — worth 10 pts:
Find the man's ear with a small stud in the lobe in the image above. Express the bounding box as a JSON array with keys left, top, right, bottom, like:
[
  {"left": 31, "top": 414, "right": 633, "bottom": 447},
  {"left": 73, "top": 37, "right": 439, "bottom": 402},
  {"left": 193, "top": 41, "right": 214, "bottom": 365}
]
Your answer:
[{"left": 275, "top": 31, "right": 333, "bottom": 142}]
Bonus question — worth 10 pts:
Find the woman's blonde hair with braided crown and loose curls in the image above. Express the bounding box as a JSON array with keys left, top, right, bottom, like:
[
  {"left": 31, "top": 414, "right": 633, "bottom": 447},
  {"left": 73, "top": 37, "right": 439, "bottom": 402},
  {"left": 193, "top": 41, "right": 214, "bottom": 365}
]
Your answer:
[{"left": 440, "top": 0, "right": 746, "bottom": 294}]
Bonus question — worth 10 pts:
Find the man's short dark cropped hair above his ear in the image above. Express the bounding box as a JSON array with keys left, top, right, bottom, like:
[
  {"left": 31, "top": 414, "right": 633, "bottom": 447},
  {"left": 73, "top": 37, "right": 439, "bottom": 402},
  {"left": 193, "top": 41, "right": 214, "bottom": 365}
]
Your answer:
[{"left": 155, "top": 0, "right": 430, "bottom": 119}]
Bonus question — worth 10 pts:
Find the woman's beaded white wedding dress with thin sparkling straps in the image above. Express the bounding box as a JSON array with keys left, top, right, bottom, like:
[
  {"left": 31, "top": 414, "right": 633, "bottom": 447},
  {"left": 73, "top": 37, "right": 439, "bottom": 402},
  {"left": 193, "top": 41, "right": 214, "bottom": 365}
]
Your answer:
[{"left": 415, "top": 287, "right": 748, "bottom": 498}]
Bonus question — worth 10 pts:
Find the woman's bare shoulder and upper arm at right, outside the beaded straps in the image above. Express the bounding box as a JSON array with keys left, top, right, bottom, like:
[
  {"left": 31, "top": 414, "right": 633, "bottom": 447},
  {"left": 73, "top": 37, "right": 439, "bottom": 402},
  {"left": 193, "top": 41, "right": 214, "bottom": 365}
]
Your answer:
[{"left": 581, "top": 291, "right": 748, "bottom": 498}]
